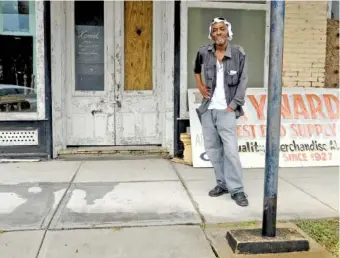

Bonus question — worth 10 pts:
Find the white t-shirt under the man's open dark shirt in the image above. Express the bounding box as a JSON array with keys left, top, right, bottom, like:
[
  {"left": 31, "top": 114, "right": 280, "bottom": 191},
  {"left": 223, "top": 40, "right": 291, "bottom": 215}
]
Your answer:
[{"left": 208, "top": 61, "right": 227, "bottom": 109}]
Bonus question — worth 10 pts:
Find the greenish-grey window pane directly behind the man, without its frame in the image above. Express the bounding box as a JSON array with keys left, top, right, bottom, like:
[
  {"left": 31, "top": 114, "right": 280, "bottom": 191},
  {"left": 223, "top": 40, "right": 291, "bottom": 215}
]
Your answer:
[{"left": 187, "top": 8, "right": 266, "bottom": 88}]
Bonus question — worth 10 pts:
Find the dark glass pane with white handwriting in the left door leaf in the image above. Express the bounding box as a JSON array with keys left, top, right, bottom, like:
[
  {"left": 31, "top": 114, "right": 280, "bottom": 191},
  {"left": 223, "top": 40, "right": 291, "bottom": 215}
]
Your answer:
[{"left": 74, "top": 1, "right": 104, "bottom": 91}]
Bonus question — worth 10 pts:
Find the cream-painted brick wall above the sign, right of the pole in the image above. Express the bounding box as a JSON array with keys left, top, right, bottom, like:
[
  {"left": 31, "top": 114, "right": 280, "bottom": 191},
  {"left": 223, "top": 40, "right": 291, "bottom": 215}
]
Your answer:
[{"left": 283, "top": 1, "right": 327, "bottom": 87}]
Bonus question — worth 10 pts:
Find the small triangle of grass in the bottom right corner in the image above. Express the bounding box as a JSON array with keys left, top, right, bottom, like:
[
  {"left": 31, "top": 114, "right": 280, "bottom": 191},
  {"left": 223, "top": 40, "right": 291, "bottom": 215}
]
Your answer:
[{"left": 294, "top": 218, "right": 339, "bottom": 257}]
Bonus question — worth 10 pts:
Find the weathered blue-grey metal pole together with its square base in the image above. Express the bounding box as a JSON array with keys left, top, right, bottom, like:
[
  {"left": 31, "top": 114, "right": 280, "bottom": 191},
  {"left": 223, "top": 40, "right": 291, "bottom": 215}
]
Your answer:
[{"left": 226, "top": 0, "right": 310, "bottom": 254}]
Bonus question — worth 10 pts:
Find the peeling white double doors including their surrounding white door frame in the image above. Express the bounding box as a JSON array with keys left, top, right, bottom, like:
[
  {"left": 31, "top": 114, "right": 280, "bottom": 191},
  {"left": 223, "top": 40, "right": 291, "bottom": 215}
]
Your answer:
[{"left": 51, "top": 1, "right": 174, "bottom": 156}]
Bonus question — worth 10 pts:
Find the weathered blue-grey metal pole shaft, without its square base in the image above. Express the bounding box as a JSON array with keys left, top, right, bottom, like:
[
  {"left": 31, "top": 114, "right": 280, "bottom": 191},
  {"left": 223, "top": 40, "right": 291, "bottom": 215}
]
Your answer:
[{"left": 262, "top": 0, "right": 285, "bottom": 237}]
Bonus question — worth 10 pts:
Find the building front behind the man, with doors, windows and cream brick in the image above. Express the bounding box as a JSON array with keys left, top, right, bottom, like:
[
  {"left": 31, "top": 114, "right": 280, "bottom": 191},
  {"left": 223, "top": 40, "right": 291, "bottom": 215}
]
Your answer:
[{"left": 0, "top": 1, "right": 334, "bottom": 158}]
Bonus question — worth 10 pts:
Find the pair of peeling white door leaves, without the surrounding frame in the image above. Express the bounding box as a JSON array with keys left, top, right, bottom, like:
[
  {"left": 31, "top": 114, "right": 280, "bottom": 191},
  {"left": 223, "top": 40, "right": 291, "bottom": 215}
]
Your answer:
[{"left": 65, "top": 1, "right": 162, "bottom": 146}]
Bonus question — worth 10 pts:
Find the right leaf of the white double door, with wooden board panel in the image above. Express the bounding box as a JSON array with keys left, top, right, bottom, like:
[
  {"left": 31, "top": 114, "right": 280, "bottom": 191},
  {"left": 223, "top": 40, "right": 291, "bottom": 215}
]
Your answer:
[{"left": 115, "top": 1, "right": 162, "bottom": 145}]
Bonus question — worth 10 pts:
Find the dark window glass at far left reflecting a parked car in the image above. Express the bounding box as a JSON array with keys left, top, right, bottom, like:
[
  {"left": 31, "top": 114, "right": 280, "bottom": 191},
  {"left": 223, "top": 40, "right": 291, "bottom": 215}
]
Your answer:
[{"left": 0, "top": 1, "right": 37, "bottom": 112}]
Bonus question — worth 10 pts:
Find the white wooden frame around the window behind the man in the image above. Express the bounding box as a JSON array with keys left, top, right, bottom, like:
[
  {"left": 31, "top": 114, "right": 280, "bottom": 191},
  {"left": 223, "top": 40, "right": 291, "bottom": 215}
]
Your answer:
[{"left": 177, "top": 0, "right": 270, "bottom": 120}]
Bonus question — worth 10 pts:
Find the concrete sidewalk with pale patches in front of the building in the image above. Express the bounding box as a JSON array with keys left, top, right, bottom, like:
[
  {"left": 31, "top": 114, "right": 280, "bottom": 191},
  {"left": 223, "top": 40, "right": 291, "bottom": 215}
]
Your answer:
[{"left": 0, "top": 159, "right": 339, "bottom": 258}]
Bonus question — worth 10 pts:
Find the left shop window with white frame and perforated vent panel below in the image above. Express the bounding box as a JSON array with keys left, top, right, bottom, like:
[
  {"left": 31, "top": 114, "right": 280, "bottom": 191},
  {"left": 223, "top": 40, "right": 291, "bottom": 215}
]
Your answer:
[{"left": 0, "top": 1, "right": 52, "bottom": 158}]
